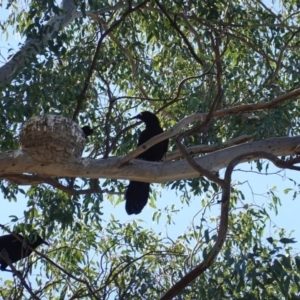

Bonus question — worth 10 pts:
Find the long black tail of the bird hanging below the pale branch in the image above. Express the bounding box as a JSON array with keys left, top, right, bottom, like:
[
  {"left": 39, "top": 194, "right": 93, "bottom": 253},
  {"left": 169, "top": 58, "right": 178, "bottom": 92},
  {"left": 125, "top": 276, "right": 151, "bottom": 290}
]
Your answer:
[{"left": 125, "top": 181, "right": 150, "bottom": 215}]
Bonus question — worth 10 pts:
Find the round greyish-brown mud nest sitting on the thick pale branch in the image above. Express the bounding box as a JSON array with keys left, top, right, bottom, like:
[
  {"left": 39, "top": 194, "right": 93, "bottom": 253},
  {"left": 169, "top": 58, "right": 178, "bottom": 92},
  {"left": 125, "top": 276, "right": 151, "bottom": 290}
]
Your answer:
[{"left": 19, "top": 115, "right": 86, "bottom": 163}]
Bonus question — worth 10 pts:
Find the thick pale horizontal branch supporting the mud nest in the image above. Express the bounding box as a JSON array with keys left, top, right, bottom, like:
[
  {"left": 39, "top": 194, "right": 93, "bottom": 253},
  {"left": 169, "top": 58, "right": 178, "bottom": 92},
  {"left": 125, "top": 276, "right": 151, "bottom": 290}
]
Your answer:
[{"left": 0, "top": 136, "right": 300, "bottom": 182}]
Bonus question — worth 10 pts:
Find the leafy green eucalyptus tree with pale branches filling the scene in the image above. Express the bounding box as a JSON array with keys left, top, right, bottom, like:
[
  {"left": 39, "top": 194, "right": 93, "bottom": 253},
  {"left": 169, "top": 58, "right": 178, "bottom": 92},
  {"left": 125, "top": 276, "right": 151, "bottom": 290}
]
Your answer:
[{"left": 0, "top": 0, "right": 300, "bottom": 299}]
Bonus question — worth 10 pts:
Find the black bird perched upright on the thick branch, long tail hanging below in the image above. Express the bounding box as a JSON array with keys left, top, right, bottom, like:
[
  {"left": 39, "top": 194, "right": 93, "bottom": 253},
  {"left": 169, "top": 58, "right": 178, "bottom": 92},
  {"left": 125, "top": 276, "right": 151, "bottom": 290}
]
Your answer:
[{"left": 125, "top": 111, "right": 168, "bottom": 215}]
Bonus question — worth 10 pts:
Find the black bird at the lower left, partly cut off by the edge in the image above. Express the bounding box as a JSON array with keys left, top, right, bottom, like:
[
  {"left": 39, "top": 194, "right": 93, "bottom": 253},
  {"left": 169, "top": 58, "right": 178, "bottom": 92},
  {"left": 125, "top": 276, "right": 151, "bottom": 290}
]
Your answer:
[{"left": 0, "top": 234, "right": 49, "bottom": 272}]
